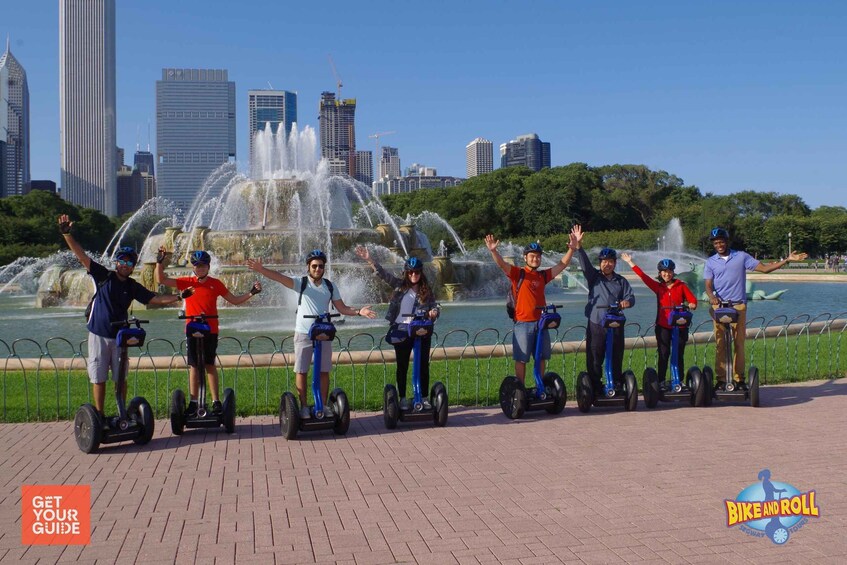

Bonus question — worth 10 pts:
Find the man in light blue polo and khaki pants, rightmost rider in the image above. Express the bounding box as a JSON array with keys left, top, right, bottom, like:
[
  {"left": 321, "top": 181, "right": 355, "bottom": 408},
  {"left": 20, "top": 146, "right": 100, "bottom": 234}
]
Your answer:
[{"left": 703, "top": 228, "right": 808, "bottom": 390}]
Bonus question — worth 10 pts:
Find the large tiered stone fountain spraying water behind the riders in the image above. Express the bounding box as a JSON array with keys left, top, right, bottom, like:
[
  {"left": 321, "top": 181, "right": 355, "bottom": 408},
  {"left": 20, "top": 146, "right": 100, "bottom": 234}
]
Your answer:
[{"left": 24, "top": 124, "right": 496, "bottom": 307}]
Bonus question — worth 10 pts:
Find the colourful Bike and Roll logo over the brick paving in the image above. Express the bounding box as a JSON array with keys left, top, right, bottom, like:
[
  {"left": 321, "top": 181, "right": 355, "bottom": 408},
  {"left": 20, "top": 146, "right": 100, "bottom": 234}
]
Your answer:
[{"left": 724, "top": 469, "right": 820, "bottom": 545}]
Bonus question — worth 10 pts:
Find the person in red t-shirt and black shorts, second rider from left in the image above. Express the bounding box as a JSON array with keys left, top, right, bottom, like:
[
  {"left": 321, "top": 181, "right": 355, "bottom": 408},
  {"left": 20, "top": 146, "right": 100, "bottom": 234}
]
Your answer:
[{"left": 156, "top": 247, "right": 262, "bottom": 415}]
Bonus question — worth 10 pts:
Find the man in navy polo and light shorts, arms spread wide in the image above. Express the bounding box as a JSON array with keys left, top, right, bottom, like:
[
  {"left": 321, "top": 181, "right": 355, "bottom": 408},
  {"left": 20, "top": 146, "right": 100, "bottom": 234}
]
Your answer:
[{"left": 59, "top": 214, "right": 193, "bottom": 417}]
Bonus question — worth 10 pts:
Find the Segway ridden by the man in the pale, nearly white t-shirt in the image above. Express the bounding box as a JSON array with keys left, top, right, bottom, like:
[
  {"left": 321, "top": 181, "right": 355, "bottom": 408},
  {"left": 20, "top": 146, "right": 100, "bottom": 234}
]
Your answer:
[{"left": 279, "top": 312, "right": 350, "bottom": 439}]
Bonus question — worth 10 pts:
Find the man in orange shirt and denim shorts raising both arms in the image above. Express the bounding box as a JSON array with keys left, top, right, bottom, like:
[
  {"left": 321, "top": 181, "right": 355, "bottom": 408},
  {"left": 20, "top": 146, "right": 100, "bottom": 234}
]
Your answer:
[{"left": 485, "top": 234, "right": 574, "bottom": 382}]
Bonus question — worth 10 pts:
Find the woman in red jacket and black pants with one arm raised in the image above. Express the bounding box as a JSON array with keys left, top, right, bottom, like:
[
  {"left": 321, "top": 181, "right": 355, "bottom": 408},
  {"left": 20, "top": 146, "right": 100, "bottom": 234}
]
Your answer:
[{"left": 621, "top": 253, "right": 697, "bottom": 388}]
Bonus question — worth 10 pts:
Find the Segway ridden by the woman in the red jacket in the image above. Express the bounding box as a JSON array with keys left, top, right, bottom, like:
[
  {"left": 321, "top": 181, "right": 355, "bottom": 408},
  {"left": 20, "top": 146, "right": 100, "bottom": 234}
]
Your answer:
[{"left": 642, "top": 305, "right": 707, "bottom": 408}]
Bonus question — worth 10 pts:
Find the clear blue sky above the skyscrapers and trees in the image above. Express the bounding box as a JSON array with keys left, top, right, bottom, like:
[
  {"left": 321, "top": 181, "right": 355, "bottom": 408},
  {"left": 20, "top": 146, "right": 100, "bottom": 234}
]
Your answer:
[{"left": 0, "top": 0, "right": 847, "bottom": 207}]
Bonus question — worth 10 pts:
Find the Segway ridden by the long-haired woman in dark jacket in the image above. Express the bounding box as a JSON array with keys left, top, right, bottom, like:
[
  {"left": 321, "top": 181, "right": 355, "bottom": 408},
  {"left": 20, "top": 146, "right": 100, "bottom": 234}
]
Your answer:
[{"left": 382, "top": 308, "right": 448, "bottom": 430}]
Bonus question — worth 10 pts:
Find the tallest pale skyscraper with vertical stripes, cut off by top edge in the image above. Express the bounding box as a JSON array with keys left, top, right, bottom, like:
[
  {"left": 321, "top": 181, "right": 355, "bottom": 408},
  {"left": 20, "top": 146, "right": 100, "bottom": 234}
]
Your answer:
[{"left": 59, "top": 0, "right": 118, "bottom": 216}]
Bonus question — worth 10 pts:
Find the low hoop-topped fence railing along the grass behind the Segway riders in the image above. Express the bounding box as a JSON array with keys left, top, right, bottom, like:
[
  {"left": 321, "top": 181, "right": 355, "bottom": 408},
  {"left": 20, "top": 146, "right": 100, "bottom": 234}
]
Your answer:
[{"left": 0, "top": 312, "right": 847, "bottom": 422}]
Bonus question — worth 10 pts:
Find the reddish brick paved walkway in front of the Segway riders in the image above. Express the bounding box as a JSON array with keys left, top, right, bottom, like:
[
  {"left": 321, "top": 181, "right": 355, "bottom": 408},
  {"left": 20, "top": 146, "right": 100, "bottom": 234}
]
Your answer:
[{"left": 0, "top": 379, "right": 847, "bottom": 564}]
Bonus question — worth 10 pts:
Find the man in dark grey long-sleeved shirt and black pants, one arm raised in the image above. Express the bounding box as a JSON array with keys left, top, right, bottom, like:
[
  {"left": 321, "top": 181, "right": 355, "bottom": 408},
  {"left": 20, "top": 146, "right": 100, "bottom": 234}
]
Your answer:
[{"left": 571, "top": 225, "right": 635, "bottom": 391}]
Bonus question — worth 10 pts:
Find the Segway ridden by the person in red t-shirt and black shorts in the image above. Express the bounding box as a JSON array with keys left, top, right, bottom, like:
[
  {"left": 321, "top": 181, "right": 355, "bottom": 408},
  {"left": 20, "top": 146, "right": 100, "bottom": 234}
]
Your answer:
[{"left": 170, "top": 313, "right": 235, "bottom": 435}]
